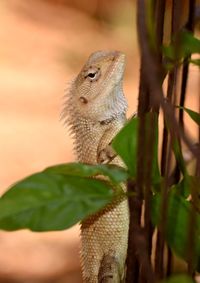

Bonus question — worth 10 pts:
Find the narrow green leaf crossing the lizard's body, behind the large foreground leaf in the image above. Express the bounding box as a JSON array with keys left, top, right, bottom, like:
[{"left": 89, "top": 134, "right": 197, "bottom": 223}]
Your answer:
[{"left": 44, "top": 163, "right": 128, "bottom": 184}]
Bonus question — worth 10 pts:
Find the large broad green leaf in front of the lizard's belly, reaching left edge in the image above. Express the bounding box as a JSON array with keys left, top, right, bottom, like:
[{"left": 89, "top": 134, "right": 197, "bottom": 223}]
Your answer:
[{"left": 0, "top": 170, "right": 114, "bottom": 231}]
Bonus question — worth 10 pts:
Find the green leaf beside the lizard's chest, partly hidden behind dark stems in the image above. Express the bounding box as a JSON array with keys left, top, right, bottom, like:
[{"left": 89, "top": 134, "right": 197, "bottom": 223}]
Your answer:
[{"left": 112, "top": 113, "right": 160, "bottom": 183}]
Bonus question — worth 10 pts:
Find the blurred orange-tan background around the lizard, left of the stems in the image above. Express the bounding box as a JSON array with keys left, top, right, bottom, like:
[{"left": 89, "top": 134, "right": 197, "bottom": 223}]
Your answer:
[{"left": 0, "top": 0, "right": 139, "bottom": 283}]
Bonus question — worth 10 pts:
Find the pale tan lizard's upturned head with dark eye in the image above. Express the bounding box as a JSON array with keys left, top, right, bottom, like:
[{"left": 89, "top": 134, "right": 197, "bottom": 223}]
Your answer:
[{"left": 71, "top": 51, "right": 127, "bottom": 121}]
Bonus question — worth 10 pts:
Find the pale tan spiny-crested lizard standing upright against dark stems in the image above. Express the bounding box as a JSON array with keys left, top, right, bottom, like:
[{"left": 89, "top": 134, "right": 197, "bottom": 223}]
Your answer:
[{"left": 63, "top": 51, "right": 129, "bottom": 283}]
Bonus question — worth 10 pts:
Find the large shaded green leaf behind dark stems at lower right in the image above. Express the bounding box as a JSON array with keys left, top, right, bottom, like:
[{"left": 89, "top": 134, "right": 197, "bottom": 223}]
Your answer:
[{"left": 151, "top": 192, "right": 200, "bottom": 271}]
